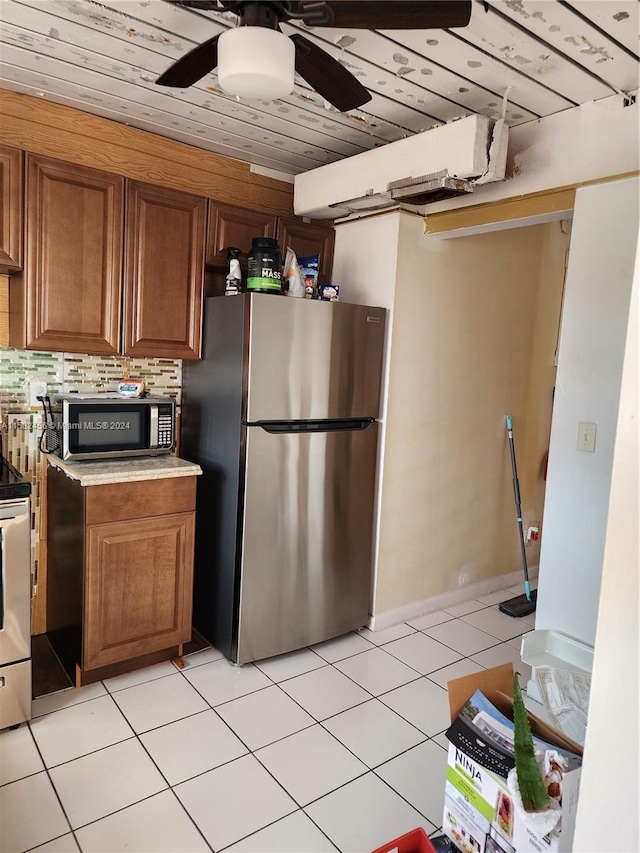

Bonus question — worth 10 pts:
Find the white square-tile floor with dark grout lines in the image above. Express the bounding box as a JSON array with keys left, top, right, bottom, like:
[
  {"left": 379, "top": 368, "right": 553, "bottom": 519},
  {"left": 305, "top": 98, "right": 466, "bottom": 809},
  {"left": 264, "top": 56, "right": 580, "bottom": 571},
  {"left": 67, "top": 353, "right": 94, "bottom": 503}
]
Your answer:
[{"left": 0, "top": 587, "right": 542, "bottom": 853}]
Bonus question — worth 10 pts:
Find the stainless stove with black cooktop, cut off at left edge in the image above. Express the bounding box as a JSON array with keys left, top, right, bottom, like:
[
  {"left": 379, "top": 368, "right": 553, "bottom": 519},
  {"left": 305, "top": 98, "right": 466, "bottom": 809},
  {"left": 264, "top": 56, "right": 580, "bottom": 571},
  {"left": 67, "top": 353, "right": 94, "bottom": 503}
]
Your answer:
[{"left": 0, "top": 456, "right": 31, "bottom": 729}]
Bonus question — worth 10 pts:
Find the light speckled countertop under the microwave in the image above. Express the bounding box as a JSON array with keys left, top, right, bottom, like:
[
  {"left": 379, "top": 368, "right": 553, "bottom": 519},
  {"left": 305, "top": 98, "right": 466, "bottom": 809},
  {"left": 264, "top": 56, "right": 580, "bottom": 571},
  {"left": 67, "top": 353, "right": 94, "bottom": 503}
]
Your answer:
[{"left": 47, "top": 454, "right": 202, "bottom": 486}]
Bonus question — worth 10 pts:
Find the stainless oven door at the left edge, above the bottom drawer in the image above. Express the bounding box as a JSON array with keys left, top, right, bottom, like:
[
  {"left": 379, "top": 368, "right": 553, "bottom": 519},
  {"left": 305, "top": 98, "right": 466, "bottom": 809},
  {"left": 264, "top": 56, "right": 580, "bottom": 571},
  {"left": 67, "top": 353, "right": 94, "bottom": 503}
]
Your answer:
[{"left": 0, "top": 498, "right": 31, "bottom": 674}]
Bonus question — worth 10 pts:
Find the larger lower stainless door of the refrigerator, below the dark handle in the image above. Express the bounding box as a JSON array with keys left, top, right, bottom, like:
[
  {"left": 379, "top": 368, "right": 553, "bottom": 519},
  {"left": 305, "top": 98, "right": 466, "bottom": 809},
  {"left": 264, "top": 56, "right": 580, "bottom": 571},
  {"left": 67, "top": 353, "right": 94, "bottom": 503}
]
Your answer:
[{"left": 234, "top": 423, "right": 378, "bottom": 664}]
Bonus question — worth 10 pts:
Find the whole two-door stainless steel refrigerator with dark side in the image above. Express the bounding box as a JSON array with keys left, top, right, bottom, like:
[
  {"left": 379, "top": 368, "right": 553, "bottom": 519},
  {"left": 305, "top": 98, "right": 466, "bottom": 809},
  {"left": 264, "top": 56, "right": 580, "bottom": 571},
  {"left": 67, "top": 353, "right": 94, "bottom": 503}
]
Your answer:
[{"left": 181, "top": 293, "right": 386, "bottom": 664}]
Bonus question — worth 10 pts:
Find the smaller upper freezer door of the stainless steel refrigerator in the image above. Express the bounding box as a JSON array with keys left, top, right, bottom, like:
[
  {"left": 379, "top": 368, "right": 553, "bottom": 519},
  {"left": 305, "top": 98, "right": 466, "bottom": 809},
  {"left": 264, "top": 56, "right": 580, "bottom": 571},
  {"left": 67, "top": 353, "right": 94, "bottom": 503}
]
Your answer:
[{"left": 246, "top": 293, "right": 386, "bottom": 423}]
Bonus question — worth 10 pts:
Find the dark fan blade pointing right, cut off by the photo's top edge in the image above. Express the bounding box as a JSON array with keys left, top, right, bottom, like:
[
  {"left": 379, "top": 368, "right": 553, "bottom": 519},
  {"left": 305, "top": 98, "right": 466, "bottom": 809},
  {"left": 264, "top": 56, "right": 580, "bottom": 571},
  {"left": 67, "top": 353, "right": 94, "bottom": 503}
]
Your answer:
[{"left": 299, "top": 0, "right": 471, "bottom": 30}]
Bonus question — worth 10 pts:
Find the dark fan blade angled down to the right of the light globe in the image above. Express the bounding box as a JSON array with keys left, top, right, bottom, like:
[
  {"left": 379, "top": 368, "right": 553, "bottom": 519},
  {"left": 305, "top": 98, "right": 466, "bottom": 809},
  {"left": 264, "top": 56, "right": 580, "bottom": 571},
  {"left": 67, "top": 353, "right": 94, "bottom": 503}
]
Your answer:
[{"left": 290, "top": 34, "right": 371, "bottom": 113}]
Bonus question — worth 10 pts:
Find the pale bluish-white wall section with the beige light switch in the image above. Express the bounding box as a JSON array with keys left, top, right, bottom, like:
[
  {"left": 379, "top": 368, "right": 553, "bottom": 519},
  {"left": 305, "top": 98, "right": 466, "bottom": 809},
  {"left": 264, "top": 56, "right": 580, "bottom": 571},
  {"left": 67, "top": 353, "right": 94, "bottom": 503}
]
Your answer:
[{"left": 536, "top": 178, "right": 639, "bottom": 645}]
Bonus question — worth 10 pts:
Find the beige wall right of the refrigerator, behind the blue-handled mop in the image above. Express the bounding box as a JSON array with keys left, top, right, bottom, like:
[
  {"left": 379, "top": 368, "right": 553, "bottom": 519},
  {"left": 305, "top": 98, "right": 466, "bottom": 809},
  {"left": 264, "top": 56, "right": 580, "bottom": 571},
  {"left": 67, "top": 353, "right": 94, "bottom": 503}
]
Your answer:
[{"left": 334, "top": 212, "right": 568, "bottom": 624}]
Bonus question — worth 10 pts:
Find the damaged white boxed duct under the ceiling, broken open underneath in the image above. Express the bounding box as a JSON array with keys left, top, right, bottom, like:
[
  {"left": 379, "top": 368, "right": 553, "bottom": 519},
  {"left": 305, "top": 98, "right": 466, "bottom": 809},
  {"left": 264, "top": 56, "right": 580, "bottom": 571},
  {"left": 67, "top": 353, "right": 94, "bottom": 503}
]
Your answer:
[{"left": 293, "top": 115, "right": 509, "bottom": 219}]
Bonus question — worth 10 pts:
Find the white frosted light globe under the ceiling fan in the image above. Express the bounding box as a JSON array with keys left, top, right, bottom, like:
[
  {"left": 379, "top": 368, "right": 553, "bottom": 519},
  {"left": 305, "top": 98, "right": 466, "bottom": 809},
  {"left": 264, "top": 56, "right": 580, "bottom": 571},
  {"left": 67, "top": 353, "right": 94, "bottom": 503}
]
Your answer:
[{"left": 218, "top": 27, "right": 295, "bottom": 98}]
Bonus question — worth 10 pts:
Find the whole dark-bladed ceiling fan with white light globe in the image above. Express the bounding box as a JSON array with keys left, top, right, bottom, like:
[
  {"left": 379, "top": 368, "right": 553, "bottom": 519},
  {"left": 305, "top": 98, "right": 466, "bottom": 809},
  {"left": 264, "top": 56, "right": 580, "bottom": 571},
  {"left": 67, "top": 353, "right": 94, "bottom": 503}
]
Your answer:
[{"left": 156, "top": 0, "right": 471, "bottom": 112}]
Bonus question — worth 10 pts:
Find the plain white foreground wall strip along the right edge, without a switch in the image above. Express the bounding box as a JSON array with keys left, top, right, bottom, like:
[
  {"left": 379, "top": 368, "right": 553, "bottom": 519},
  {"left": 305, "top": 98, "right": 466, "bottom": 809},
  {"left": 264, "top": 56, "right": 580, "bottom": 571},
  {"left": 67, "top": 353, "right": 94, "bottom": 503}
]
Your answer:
[{"left": 574, "top": 235, "right": 640, "bottom": 853}]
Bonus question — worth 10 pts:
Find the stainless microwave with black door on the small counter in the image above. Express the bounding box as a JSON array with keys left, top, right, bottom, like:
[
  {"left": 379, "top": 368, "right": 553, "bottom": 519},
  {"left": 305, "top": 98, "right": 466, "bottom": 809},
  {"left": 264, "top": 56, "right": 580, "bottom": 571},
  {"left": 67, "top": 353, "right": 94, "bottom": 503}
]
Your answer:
[{"left": 53, "top": 394, "right": 176, "bottom": 459}]
